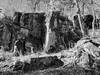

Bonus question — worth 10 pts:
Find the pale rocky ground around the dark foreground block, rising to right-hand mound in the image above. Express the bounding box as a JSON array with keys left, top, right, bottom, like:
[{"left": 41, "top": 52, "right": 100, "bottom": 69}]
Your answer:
[{"left": 0, "top": 31, "right": 100, "bottom": 75}]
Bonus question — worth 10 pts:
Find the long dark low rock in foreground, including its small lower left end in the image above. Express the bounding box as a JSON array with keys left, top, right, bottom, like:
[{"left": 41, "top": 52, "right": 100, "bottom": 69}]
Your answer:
[{"left": 13, "top": 56, "right": 64, "bottom": 72}]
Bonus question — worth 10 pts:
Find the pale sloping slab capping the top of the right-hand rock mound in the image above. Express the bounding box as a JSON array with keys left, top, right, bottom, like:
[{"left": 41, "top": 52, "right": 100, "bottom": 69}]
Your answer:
[{"left": 75, "top": 39, "right": 100, "bottom": 58}]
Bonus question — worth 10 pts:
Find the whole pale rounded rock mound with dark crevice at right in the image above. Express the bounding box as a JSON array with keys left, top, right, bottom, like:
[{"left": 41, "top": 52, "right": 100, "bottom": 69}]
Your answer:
[{"left": 76, "top": 39, "right": 100, "bottom": 69}]
